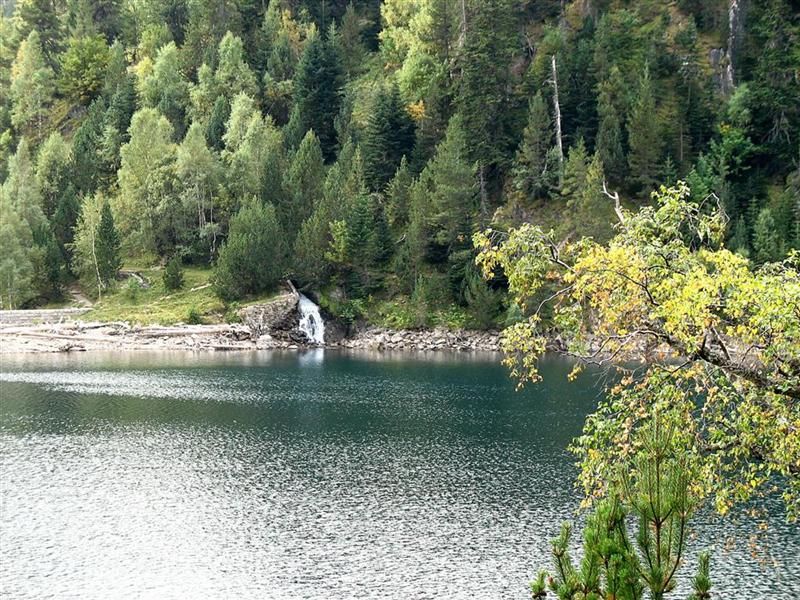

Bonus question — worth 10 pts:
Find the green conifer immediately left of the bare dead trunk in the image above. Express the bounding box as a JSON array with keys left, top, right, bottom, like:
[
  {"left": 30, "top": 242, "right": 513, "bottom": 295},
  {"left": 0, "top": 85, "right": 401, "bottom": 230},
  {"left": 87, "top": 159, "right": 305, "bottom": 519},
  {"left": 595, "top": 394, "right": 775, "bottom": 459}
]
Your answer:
[{"left": 511, "top": 92, "right": 558, "bottom": 202}]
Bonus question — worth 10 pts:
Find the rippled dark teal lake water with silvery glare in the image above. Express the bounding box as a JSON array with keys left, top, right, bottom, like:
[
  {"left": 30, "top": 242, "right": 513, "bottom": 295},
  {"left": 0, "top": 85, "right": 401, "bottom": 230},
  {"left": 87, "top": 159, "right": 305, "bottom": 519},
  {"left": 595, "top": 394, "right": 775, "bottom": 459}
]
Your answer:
[{"left": 0, "top": 350, "right": 800, "bottom": 600}]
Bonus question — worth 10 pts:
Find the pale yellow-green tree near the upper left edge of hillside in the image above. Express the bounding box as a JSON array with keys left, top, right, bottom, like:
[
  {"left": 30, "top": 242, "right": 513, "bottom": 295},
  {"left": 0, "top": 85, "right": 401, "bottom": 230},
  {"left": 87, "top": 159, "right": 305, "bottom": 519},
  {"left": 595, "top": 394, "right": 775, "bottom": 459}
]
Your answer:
[{"left": 9, "top": 29, "right": 54, "bottom": 136}]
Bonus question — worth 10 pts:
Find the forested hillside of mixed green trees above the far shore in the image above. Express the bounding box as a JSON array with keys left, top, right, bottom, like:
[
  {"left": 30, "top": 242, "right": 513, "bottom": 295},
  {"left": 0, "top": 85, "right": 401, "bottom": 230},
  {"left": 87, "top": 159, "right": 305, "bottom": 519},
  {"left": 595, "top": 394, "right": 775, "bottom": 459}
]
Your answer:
[{"left": 0, "top": 0, "right": 800, "bottom": 327}]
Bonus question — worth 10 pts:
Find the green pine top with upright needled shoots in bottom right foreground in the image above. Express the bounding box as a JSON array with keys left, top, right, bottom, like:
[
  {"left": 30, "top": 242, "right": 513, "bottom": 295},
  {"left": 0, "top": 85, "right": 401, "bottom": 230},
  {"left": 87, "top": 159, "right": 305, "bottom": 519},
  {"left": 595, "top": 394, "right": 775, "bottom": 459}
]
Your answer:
[{"left": 530, "top": 416, "right": 711, "bottom": 600}]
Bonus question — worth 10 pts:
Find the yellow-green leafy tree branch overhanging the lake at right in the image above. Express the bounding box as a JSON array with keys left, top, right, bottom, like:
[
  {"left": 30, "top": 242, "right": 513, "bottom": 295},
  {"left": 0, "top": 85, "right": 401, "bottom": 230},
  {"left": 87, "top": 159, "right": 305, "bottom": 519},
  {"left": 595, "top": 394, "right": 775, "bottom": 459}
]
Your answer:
[{"left": 474, "top": 183, "right": 800, "bottom": 519}]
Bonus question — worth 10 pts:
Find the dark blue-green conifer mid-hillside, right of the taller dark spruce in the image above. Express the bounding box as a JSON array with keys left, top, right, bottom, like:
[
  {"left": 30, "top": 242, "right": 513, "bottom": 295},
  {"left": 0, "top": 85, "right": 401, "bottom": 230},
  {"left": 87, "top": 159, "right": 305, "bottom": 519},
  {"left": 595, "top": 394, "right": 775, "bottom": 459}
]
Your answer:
[{"left": 361, "top": 83, "right": 414, "bottom": 191}]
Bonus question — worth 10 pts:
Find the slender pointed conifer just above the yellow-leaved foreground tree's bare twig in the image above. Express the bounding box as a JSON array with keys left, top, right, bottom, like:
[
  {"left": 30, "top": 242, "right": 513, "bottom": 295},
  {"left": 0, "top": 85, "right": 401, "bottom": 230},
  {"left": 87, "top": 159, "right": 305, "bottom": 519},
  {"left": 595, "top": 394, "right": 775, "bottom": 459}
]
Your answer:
[{"left": 628, "top": 67, "right": 662, "bottom": 193}]
